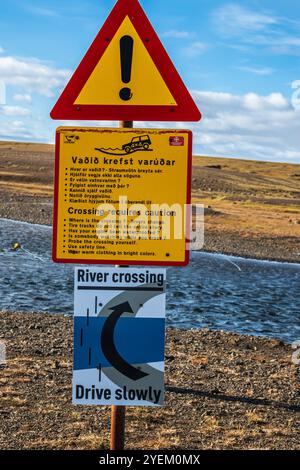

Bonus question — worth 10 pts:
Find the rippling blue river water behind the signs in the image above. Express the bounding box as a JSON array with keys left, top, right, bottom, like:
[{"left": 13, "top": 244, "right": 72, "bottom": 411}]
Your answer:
[{"left": 0, "top": 219, "right": 300, "bottom": 342}]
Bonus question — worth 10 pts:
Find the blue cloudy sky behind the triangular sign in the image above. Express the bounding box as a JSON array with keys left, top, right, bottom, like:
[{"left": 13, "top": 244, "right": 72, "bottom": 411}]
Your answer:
[{"left": 0, "top": 0, "right": 300, "bottom": 163}]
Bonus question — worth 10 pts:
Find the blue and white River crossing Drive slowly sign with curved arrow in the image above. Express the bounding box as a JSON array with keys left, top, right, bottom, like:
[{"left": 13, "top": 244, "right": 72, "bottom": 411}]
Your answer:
[{"left": 73, "top": 267, "right": 166, "bottom": 406}]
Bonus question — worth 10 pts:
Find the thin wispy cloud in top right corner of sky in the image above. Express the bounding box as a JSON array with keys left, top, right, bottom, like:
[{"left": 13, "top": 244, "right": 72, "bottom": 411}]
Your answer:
[{"left": 213, "top": 3, "right": 300, "bottom": 55}]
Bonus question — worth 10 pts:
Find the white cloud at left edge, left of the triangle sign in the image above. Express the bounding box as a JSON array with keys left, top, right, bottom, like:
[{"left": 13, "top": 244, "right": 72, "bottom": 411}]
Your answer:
[{"left": 0, "top": 57, "right": 70, "bottom": 97}]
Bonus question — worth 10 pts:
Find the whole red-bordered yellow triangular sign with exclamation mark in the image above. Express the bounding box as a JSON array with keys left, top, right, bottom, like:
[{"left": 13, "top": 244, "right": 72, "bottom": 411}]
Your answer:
[{"left": 51, "top": 0, "right": 201, "bottom": 121}]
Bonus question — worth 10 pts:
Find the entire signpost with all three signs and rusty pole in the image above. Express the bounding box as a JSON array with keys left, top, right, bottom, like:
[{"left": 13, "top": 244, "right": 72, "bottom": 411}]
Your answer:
[{"left": 51, "top": 0, "right": 201, "bottom": 450}]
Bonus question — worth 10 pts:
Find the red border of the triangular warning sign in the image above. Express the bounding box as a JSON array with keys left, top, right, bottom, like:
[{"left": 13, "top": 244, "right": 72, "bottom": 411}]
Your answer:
[{"left": 50, "top": 0, "right": 201, "bottom": 121}]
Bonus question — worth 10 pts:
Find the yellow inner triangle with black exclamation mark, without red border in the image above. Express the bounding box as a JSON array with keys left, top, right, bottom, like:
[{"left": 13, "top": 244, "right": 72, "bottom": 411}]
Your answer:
[{"left": 75, "top": 16, "right": 176, "bottom": 106}]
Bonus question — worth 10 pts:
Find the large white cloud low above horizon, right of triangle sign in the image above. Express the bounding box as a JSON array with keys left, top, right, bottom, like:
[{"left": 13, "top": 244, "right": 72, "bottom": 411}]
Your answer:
[{"left": 191, "top": 91, "right": 300, "bottom": 163}]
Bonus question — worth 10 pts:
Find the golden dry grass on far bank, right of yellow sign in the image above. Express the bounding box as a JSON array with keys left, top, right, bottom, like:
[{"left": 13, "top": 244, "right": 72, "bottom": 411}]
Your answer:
[{"left": 192, "top": 157, "right": 300, "bottom": 244}]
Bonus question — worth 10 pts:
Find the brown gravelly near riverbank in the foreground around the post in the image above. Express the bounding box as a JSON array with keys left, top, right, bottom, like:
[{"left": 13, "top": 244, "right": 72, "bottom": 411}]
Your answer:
[{"left": 0, "top": 313, "right": 300, "bottom": 449}]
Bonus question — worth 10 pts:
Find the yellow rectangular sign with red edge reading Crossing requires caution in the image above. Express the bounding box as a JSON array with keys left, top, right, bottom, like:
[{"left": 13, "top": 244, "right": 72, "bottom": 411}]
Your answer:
[{"left": 53, "top": 127, "right": 192, "bottom": 265}]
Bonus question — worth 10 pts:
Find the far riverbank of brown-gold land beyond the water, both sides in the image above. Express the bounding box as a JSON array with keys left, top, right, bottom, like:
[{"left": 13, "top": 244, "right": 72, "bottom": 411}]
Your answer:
[{"left": 0, "top": 142, "right": 300, "bottom": 262}]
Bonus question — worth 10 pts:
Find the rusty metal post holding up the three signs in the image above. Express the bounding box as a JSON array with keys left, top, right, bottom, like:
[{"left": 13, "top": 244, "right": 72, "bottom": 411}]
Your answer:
[{"left": 110, "top": 121, "right": 133, "bottom": 450}]
